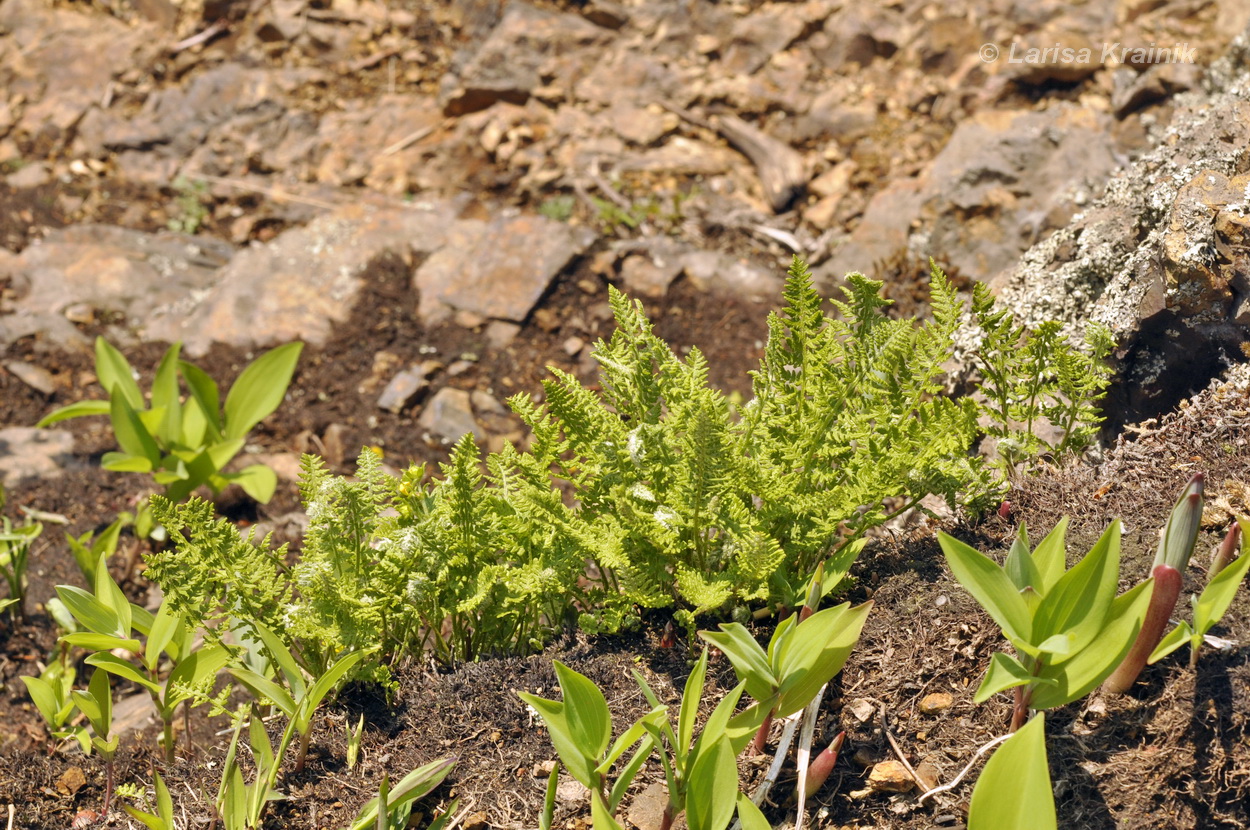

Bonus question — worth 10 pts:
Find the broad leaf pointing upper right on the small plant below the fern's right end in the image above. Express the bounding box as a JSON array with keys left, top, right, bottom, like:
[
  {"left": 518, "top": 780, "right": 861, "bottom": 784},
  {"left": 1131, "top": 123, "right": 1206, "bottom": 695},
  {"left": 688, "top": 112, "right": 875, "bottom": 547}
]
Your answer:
[{"left": 775, "top": 600, "right": 873, "bottom": 718}]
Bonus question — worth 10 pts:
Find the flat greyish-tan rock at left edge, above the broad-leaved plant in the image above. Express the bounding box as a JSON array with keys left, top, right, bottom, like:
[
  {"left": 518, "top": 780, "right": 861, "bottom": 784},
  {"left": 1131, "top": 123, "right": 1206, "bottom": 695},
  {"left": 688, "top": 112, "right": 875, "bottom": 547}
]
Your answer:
[{"left": 0, "top": 225, "right": 233, "bottom": 346}]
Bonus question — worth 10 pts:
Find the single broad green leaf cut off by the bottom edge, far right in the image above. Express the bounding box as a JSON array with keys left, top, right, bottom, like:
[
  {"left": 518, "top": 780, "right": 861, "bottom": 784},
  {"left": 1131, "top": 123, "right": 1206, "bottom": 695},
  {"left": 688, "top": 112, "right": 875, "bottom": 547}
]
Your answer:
[{"left": 968, "top": 714, "right": 1059, "bottom": 830}]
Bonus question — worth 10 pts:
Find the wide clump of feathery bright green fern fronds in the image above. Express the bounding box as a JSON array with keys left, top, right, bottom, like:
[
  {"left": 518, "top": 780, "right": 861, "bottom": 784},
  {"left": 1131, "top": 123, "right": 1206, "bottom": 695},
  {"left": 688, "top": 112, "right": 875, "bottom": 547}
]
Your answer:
[{"left": 150, "top": 252, "right": 1111, "bottom": 664}]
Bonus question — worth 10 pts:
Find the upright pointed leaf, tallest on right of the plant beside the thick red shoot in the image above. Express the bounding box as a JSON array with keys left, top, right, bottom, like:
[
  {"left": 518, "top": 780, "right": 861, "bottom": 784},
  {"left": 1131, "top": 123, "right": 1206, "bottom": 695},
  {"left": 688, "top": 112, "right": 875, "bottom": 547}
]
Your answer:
[{"left": 1033, "top": 520, "right": 1120, "bottom": 663}]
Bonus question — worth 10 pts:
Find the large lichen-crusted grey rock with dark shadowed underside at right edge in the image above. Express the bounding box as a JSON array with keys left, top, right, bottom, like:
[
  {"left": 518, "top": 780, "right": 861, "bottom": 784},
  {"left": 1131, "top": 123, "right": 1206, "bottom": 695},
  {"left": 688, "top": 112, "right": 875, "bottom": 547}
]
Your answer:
[{"left": 996, "top": 30, "right": 1250, "bottom": 419}]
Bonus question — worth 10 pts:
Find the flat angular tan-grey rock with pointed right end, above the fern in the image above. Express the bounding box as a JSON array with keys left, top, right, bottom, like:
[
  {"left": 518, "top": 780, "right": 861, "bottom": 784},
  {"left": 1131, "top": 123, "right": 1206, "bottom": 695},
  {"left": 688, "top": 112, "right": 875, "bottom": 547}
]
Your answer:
[{"left": 413, "top": 215, "right": 594, "bottom": 323}]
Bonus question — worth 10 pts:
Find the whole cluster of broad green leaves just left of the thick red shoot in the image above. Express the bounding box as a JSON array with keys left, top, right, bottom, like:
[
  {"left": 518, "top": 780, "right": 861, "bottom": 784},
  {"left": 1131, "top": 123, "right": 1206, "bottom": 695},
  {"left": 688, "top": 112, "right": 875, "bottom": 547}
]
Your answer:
[{"left": 938, "top": 519, "right": 1151, "bottom": 731}]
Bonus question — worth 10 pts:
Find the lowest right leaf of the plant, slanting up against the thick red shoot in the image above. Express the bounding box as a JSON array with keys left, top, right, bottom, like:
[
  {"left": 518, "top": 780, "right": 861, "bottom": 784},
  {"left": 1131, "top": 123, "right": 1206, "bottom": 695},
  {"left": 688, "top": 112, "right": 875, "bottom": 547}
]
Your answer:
[{"left": 1029, "top": 579, "right": 1154, "bottom": 709}]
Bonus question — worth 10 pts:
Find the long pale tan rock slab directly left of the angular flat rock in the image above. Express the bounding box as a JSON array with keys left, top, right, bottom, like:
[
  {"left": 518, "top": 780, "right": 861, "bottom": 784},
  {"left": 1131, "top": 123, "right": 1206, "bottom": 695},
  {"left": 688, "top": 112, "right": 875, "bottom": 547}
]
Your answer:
[{"left": 146, "top": 204, "right": 451, "bottom": 355}]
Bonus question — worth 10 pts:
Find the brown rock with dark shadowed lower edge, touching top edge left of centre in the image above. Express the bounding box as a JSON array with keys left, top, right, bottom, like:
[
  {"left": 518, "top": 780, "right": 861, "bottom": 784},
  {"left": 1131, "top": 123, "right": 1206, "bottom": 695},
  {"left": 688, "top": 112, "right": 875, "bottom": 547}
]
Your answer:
[{"left": 440, "top": 0, "right": 608, "bottom": 115}]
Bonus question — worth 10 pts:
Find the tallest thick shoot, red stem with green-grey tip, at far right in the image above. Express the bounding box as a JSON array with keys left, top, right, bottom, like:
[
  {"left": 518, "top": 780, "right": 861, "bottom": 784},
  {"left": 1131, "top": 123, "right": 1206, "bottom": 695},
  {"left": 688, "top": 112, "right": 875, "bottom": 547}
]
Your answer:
[{"left": 1103, "top": 473, "right": 1203, "bottom": 694}]
